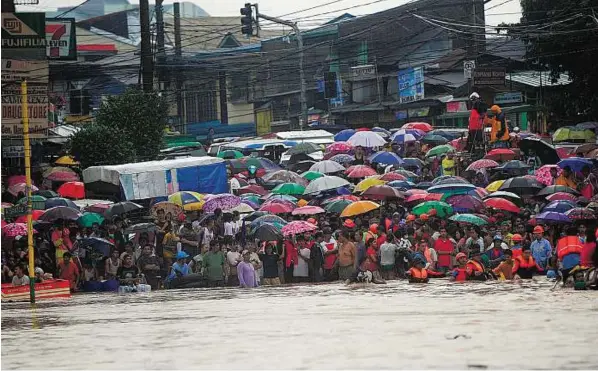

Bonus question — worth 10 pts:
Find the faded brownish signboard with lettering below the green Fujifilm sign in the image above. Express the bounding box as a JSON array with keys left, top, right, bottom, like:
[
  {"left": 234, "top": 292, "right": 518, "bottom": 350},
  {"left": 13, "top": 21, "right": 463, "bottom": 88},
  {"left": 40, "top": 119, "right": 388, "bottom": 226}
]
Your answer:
[{"left": 2, "top": 59, "right": 48, "bottom": 138}]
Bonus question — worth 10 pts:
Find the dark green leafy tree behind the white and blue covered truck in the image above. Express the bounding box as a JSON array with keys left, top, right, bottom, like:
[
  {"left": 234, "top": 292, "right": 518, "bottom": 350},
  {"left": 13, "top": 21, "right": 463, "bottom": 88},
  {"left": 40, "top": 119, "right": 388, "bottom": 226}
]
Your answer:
[{"left": 71, "top": 89, "right": 168, "bottom": 168}]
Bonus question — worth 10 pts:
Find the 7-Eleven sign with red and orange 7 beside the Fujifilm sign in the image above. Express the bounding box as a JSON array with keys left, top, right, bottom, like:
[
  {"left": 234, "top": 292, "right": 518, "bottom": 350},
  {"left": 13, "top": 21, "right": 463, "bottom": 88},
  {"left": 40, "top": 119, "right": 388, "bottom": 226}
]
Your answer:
[{"left": 46, "top": 18, "right": 77, "bottom": 60}]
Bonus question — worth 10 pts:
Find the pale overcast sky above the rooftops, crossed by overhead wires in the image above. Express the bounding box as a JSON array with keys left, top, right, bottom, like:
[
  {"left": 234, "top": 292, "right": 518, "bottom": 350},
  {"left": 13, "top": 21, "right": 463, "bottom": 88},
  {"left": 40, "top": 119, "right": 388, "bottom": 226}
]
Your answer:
[{"left": 18, "top": 0, "right": 521, "bottom": 27}]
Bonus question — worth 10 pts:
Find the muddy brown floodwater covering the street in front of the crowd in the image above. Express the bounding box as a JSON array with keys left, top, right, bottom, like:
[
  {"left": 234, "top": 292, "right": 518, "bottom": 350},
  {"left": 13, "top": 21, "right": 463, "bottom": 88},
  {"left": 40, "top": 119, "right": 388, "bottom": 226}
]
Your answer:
[{"left": 2, "top": 280, "right": 598, "bottom": 369}]
